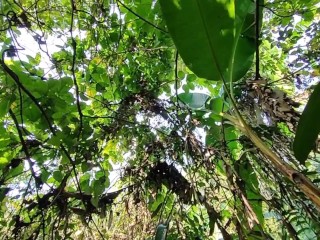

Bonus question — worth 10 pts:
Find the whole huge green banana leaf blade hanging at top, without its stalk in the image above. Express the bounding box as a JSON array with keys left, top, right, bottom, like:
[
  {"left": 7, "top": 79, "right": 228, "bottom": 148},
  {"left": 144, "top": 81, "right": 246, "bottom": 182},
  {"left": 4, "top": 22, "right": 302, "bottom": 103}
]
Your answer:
[{"left": 160, "top": 0, "right": 262, "bottom": 80}]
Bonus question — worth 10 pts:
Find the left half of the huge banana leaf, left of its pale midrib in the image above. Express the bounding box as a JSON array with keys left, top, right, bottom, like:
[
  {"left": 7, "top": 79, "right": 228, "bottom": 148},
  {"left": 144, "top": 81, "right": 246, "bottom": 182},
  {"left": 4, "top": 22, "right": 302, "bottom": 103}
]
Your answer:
[{"left": 160, "top": 0, "right": 235, "bottom": 80}]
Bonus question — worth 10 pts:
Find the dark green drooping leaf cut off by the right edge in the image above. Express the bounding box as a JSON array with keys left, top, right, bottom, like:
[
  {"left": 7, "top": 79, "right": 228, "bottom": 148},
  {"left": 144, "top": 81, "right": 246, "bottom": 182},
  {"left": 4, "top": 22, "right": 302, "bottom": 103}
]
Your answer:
[{"left": 293, "top": 83, "right": 320, "bottom": 164}]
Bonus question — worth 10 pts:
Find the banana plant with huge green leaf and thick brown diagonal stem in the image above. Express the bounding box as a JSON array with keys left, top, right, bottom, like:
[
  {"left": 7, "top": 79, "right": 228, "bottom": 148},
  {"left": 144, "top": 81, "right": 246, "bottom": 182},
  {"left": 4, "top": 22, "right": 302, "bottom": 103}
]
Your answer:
[{"left": 160, "top": 0, "right": 320, "bottom": 209}]
